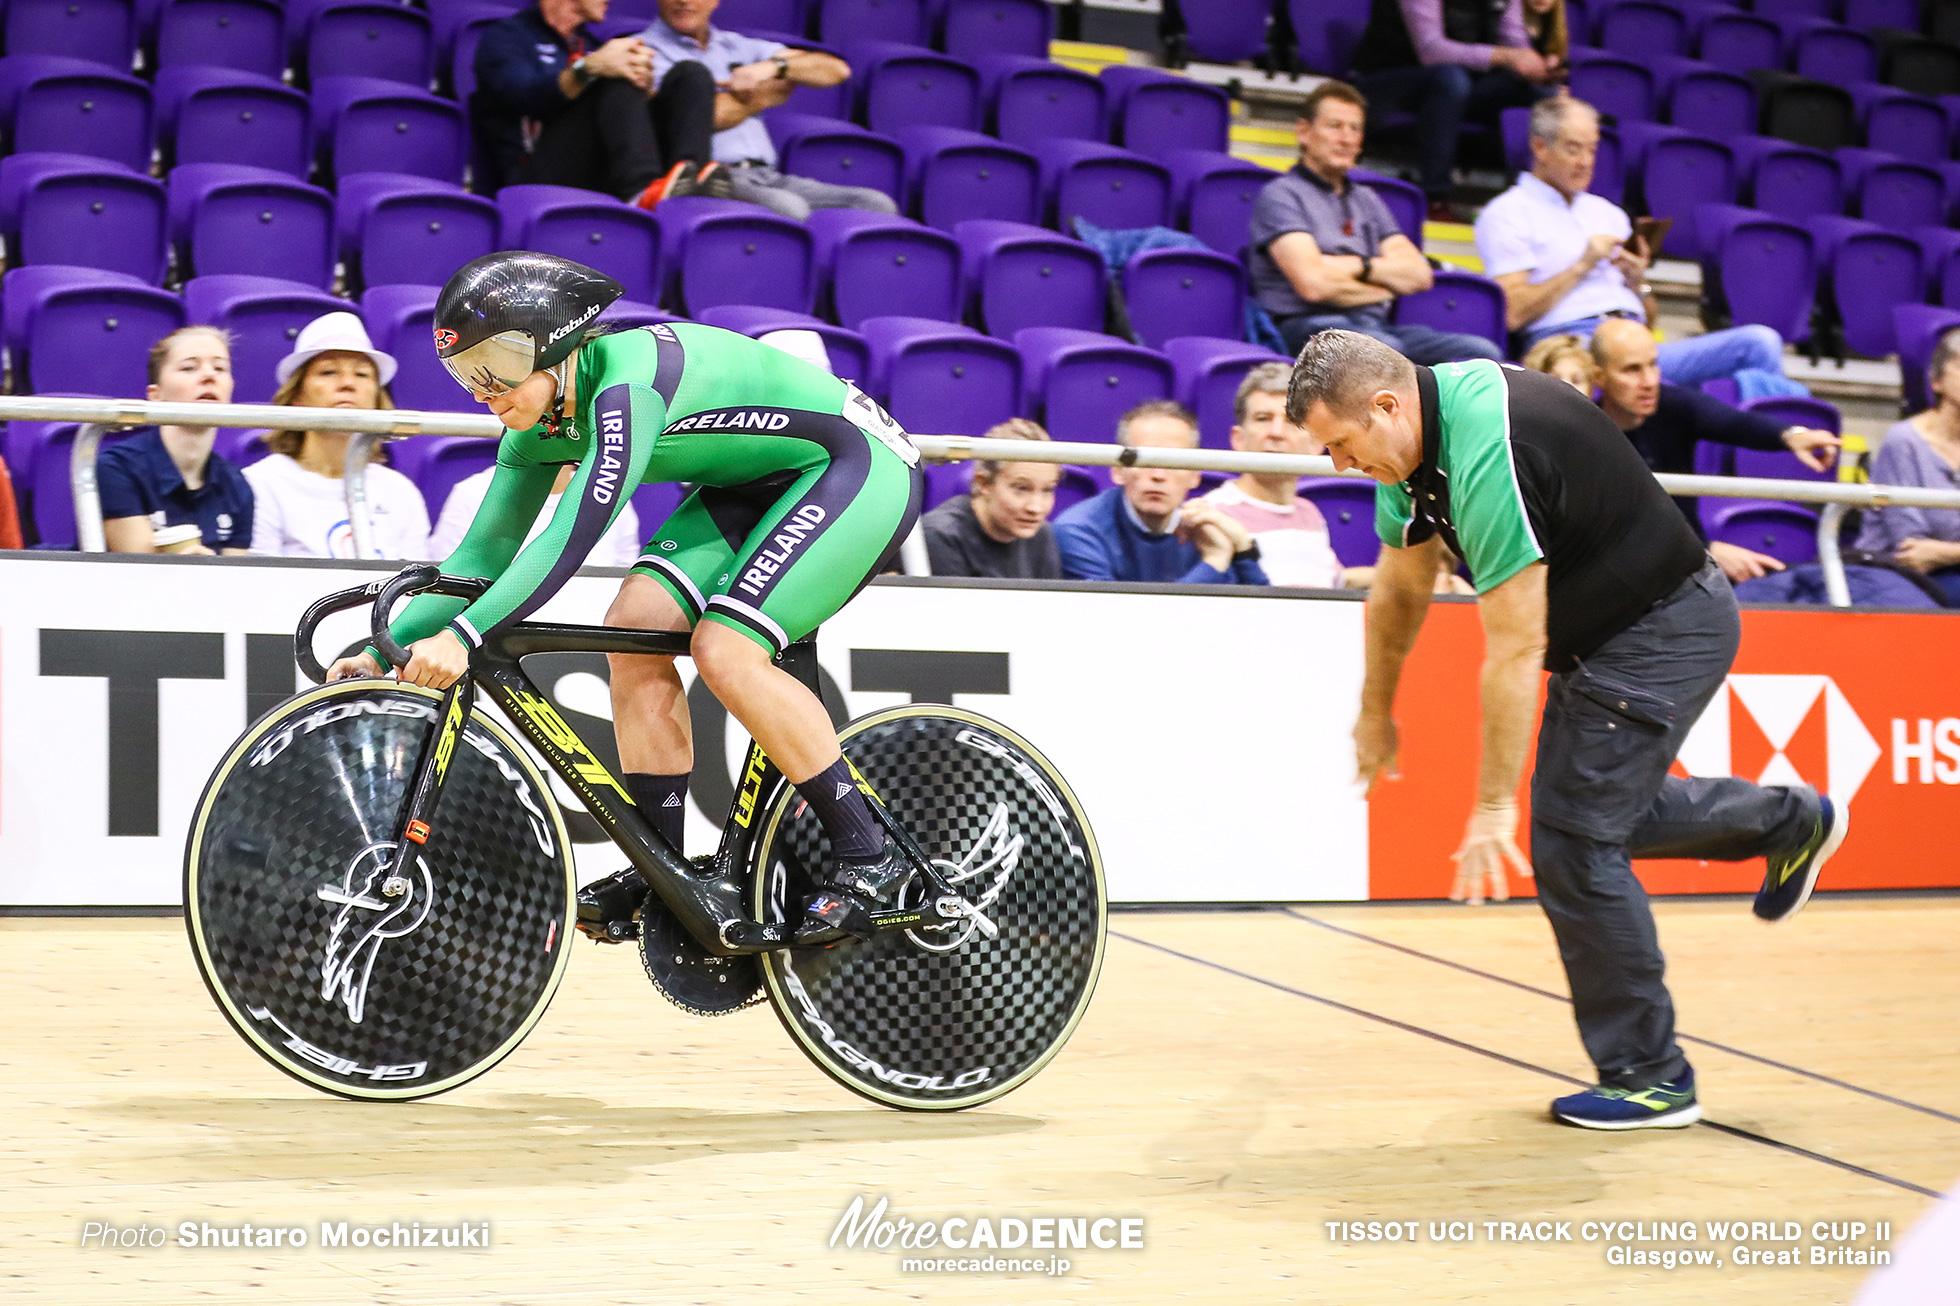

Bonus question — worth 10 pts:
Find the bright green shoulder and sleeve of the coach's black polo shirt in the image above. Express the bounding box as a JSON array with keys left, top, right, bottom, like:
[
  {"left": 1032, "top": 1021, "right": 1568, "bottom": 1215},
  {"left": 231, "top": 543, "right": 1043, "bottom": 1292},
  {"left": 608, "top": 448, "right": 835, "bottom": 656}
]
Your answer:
[{"left": 1435, "top": 359, "right": 1544, "bottom": 594}]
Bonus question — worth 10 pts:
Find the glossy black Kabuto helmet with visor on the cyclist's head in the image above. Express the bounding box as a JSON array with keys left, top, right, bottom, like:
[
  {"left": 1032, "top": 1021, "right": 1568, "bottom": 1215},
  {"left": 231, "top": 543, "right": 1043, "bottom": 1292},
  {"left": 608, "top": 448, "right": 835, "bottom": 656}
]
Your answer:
[{"left": 435, "top": 249, "right": 625, "bottom": 394}]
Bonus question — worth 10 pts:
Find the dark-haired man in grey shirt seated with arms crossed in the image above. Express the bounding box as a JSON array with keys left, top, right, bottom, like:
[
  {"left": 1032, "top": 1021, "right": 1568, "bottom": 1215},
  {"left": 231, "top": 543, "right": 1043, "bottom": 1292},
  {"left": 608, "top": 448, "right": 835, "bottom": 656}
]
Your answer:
[{"left": 1249, "top": 80, "right": 1503, "bottom": 363}]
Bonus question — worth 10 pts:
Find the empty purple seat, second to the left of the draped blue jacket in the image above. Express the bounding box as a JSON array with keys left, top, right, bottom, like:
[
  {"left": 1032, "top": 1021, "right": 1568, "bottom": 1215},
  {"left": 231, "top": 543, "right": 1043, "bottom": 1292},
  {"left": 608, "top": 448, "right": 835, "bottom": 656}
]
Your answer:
[{"left": 808, "top": 208, "right": 964, "bottom": 329}]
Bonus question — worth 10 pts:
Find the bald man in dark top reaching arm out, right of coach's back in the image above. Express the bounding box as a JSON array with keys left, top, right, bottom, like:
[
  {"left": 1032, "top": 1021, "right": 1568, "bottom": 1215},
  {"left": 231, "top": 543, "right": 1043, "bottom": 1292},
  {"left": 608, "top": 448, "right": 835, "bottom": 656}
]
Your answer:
[{"left": 1592, "top": 322, "right": 1840, "bottom": 580}]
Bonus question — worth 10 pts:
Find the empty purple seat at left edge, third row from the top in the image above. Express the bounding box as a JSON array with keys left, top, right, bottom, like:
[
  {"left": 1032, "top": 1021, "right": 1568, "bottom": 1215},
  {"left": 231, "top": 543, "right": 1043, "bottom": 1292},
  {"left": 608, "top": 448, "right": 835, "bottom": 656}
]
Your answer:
[{"left": 0, "top": 153, "right": 167, "bottom": 284}]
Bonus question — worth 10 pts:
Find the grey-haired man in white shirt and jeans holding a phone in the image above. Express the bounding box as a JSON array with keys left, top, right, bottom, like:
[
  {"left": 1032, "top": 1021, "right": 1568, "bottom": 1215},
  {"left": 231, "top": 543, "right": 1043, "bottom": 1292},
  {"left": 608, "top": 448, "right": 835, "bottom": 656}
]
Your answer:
[{"left": 1476, "top": 96, "right": 1788, "bottom": 392}]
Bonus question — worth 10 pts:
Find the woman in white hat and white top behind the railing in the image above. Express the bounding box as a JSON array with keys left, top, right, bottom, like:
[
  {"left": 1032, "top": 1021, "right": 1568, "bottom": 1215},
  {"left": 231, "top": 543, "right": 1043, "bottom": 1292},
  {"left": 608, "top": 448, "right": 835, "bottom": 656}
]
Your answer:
[{"left": 245, "top": 314, "right": 433, "bottom": 561}]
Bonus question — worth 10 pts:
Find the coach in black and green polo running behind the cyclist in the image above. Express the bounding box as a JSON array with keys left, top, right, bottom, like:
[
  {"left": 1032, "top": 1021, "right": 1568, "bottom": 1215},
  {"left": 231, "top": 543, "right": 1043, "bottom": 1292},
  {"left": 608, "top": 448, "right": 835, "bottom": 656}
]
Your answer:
[{"left": 1286, "top": 331, "right": 1846, "bottom": 1130}]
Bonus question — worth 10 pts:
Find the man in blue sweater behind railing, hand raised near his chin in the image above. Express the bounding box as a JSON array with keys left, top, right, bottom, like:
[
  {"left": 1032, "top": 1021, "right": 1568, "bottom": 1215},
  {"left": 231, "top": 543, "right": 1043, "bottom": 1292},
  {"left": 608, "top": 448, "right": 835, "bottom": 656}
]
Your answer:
[{"left": 1054, "top": 400, "right": 1268, "bottom": 584}]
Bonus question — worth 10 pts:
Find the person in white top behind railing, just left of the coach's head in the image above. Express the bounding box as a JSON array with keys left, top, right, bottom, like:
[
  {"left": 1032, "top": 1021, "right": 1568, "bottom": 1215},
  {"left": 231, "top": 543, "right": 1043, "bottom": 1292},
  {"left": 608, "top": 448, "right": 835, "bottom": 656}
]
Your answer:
[{"left": 1198, "top": 363, "right": 1360, "bottom": 590}]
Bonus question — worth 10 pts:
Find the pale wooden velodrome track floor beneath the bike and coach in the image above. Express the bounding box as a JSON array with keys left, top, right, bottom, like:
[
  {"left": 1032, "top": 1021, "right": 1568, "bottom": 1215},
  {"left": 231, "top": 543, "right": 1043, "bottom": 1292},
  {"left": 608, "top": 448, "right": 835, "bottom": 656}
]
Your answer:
[{"left": 0, "top": 898, "right": 1960, "bottom": 1306}]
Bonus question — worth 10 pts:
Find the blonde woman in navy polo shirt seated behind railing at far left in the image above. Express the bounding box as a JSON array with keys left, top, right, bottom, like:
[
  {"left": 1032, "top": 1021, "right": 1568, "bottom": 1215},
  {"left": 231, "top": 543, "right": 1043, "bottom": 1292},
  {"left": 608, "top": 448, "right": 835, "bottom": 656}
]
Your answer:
[{"left": 96, "top": 326, "right": 253, "bottom": 555}]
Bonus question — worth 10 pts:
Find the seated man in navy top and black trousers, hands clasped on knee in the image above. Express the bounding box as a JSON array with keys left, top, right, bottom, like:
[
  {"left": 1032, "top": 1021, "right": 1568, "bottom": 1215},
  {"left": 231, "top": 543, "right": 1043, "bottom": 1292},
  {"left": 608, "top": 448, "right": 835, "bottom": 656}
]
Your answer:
[{"left": 470, "top": 0, "right": 731, "bottom": 208}]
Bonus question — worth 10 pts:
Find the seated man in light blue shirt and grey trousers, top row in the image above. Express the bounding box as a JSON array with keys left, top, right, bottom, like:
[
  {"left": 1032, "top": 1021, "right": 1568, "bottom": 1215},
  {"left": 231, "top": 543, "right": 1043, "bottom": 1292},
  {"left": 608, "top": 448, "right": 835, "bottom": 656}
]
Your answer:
[{"left": 639, "top": 0, "right": 898, "bottom": 222}]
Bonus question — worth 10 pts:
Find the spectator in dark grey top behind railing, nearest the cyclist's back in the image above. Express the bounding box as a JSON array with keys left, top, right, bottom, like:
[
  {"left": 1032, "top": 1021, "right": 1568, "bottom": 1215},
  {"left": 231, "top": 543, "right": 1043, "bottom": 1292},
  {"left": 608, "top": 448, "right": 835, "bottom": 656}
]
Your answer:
[{"left": 919, "top": 418, "right": 1062, "bottom": 580}]
